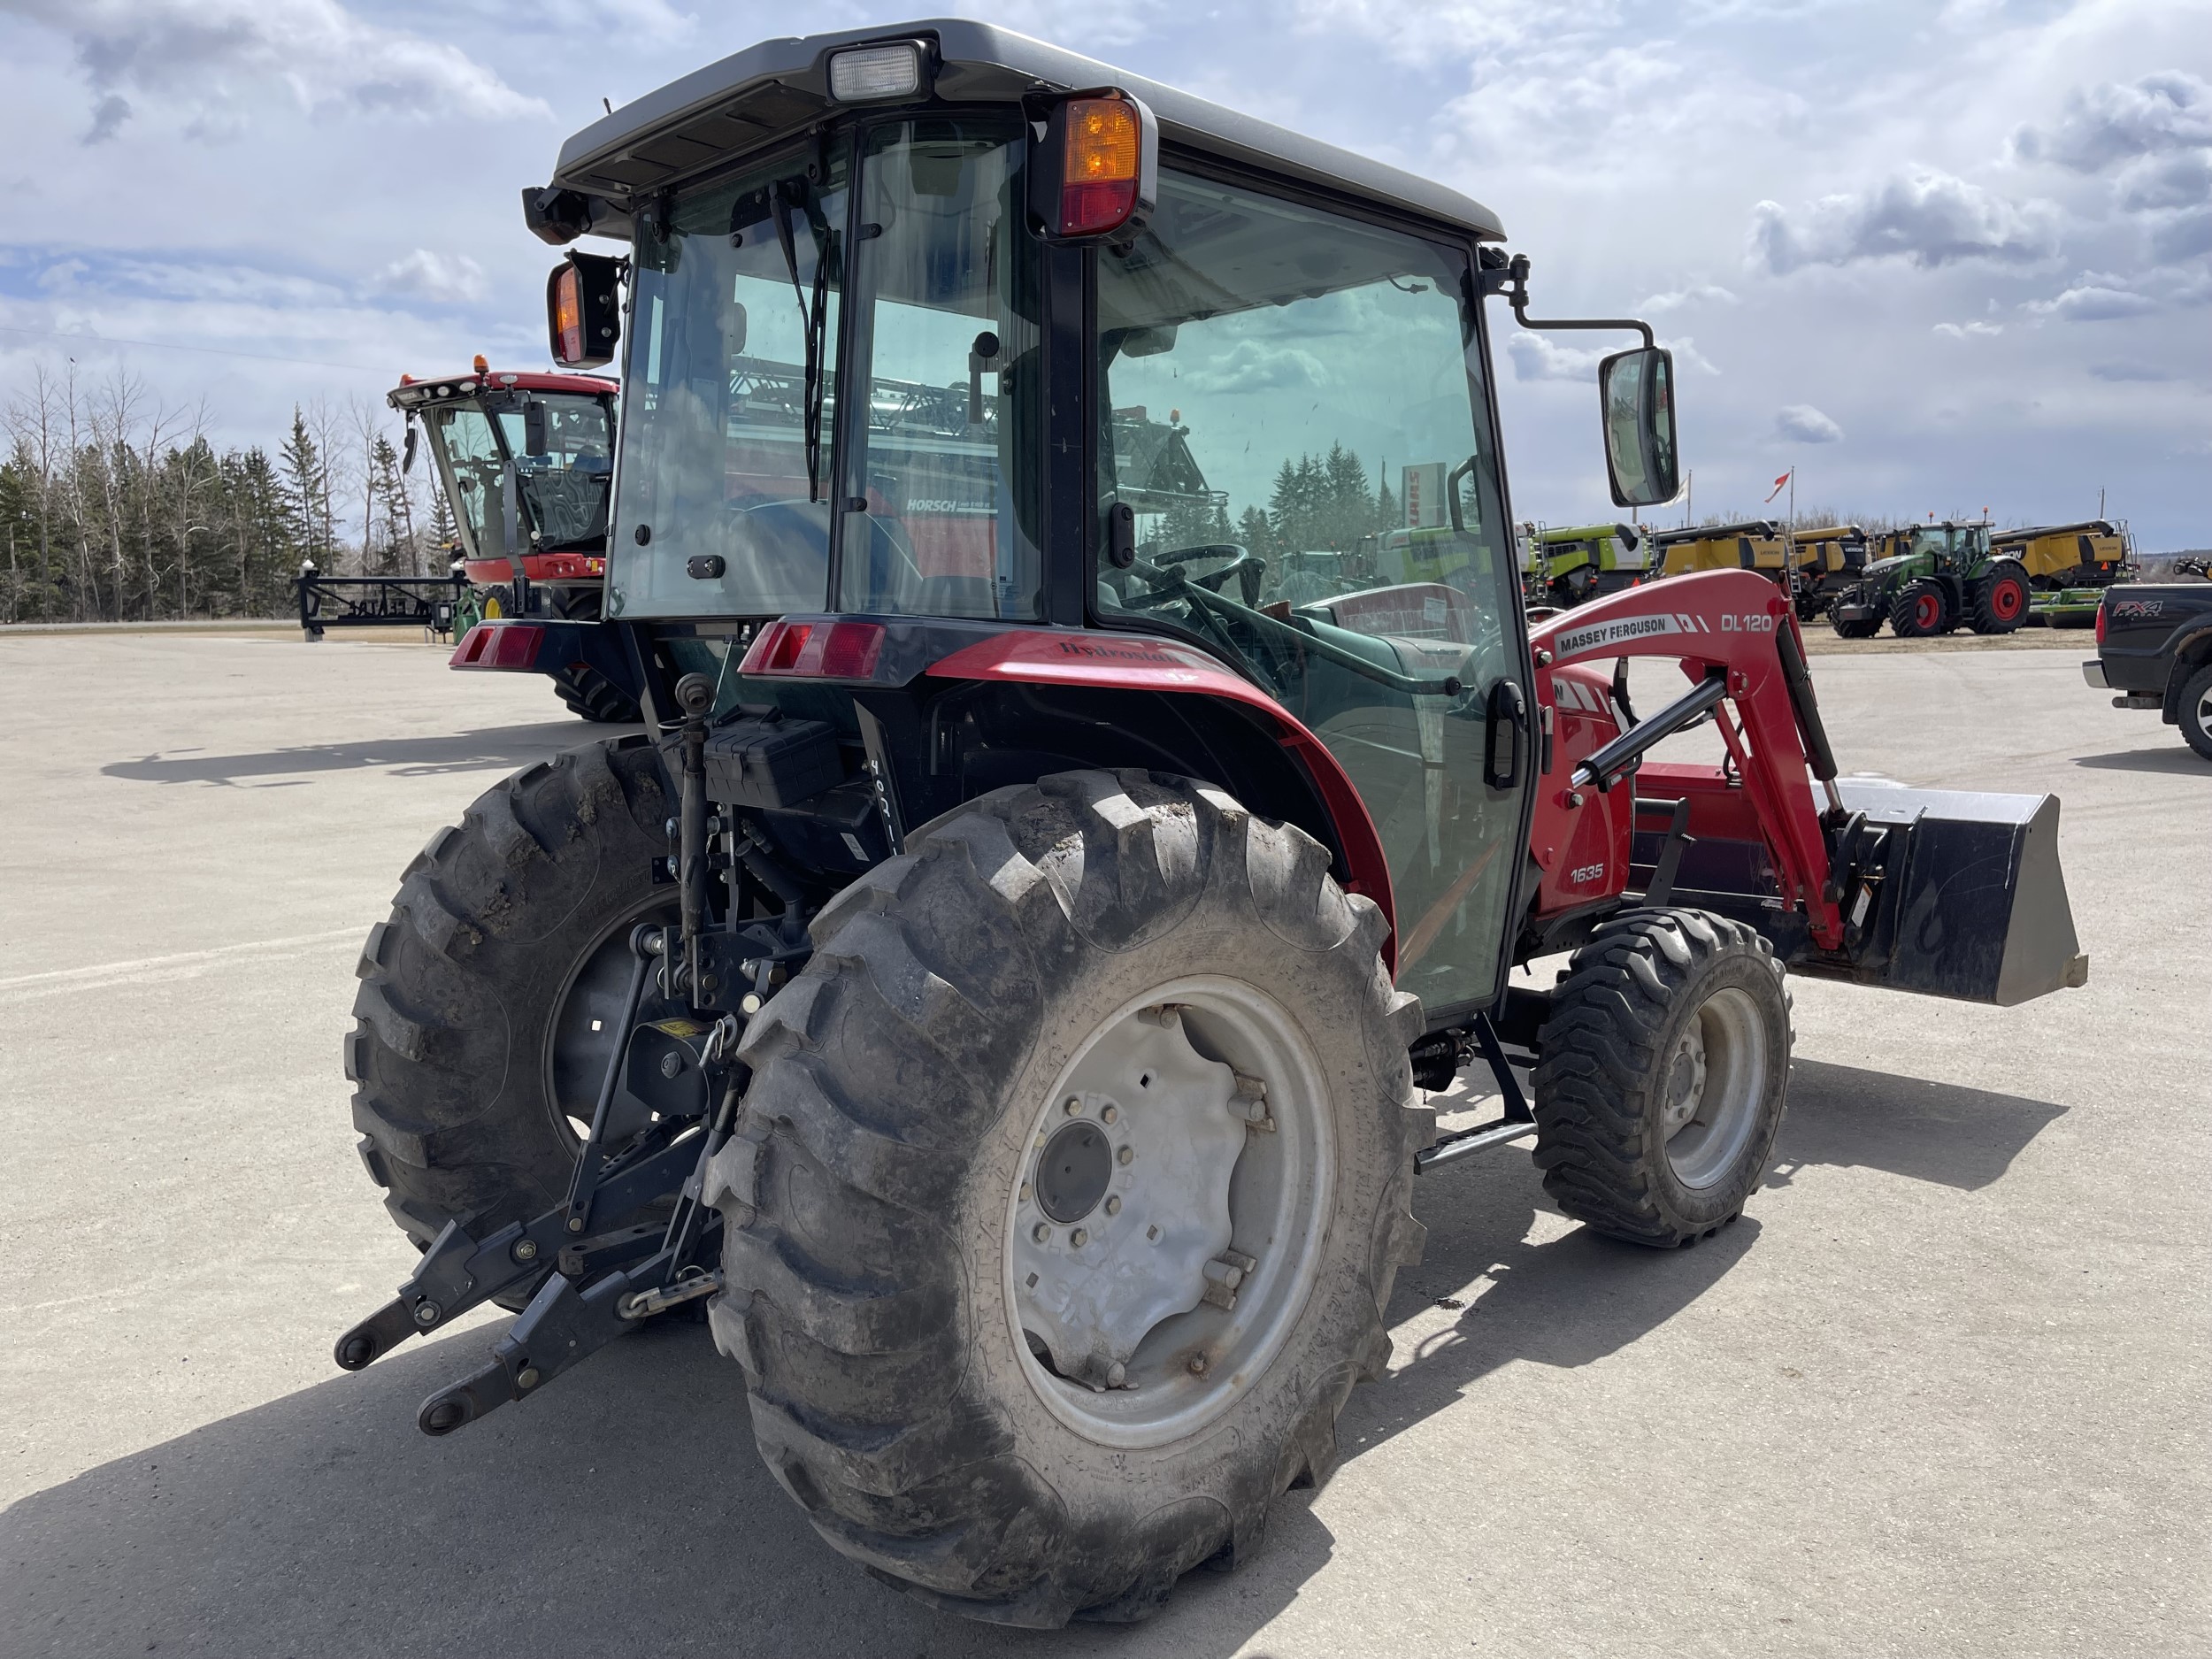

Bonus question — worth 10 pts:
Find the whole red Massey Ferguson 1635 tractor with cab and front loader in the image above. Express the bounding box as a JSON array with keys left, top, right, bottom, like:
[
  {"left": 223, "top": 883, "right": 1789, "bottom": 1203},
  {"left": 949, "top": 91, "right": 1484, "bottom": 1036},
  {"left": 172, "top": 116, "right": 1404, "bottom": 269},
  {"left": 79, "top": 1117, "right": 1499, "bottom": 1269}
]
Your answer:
[{"left": 336, "top": 20, "right": 2086, "bottom": 1626}]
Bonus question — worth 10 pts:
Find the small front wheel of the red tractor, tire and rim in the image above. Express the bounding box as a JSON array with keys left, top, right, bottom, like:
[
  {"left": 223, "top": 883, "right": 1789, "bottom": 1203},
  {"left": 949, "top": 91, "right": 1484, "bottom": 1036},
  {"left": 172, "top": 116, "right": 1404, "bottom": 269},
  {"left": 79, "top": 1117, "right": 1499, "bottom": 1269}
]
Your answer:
[{"left": 1535, "top": 910, "right": 1792, "bottom": 1248}]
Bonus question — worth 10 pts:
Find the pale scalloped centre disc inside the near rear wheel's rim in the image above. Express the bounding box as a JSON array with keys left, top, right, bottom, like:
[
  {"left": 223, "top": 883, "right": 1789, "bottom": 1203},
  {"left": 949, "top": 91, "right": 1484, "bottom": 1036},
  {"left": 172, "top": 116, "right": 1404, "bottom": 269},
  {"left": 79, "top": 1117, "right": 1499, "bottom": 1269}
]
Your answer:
[{"left": 1013, "top": 1009, "right": 1250, "bottom": 1389}]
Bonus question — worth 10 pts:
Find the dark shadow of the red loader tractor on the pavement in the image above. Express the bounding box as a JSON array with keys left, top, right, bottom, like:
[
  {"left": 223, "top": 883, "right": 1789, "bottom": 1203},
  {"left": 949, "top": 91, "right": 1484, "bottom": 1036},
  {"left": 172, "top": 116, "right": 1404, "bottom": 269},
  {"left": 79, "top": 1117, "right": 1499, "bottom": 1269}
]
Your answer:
[{"left": 0, "top": 1062, "right": 2062, "bottom": 1659}]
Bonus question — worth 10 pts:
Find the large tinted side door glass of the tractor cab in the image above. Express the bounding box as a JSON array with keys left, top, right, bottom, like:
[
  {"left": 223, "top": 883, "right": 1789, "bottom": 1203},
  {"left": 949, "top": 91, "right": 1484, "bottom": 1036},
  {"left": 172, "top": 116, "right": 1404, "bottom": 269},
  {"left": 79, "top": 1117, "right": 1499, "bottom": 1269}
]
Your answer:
[{"left": 1097, "top": 175, "right": 1520, "bottom": 1011}]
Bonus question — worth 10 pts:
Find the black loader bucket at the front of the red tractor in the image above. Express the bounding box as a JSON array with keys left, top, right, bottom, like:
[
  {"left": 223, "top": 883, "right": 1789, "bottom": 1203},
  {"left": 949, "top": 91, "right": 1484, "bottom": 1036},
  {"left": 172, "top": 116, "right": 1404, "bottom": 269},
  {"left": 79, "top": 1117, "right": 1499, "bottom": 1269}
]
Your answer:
[{"left": 1792, "top": 779, "right": 2088, "bottom": 1009}]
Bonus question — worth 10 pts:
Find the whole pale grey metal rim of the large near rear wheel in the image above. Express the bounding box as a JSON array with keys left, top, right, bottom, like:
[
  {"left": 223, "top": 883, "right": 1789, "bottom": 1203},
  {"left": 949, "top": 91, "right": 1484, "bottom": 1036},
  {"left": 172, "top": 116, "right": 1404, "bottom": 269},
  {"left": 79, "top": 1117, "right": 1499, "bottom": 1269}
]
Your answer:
[{"left": 1002, "top": 976, "right": 1336, "bottom": 1447}]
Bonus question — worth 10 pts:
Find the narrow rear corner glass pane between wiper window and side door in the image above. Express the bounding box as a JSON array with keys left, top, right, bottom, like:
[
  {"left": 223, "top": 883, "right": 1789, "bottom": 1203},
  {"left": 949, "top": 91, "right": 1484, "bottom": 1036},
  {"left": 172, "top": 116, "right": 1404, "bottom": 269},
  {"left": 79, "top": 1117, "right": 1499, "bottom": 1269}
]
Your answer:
[{"left": 841, "top": 119, "right": 1042, "bottom": 618}]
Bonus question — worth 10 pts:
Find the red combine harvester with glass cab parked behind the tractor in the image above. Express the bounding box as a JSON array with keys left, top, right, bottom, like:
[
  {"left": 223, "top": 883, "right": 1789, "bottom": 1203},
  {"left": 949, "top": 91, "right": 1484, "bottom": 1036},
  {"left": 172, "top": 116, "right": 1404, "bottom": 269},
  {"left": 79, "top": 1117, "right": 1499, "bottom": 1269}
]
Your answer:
[{"left": 385, "top": 358, "right": 641, "bottom": 724}]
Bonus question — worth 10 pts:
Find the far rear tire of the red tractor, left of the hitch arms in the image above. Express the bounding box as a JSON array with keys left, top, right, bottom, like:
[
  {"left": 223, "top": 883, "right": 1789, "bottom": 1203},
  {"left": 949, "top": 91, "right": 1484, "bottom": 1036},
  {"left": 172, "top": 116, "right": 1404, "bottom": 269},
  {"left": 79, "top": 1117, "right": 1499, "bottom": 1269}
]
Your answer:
[{"left": 345, "top": 737, "right": 672, "bottom": 1305}]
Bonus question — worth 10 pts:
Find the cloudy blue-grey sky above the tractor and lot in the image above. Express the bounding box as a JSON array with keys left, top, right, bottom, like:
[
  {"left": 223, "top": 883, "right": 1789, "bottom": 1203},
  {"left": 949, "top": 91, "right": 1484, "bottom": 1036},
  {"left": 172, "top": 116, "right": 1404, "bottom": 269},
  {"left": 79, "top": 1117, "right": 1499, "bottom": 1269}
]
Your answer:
[{"left": 0, "top": 0, "right": 2212, "bottom": 551}]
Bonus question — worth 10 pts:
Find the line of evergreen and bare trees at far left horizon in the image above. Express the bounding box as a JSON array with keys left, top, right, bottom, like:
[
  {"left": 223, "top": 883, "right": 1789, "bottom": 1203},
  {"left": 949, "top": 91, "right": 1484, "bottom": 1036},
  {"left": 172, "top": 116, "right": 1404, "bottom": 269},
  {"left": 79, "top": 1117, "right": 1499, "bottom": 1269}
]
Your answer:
[{"left": 0, "top": 365, "right": 454, "bottom": 622}]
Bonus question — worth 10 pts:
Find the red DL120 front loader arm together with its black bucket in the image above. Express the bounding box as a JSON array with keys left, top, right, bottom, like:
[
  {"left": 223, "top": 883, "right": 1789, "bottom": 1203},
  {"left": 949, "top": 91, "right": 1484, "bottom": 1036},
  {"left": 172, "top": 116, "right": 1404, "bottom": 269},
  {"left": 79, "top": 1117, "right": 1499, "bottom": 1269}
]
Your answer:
[{"left": 1531, "top": 571, "right": 2088, "bottom": 1007}]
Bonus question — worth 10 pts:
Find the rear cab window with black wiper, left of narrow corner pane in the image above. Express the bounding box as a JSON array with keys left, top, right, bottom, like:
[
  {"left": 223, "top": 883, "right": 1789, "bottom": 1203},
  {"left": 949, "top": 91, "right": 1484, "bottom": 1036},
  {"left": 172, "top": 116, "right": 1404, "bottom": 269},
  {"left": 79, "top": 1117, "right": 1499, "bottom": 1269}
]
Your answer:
[{"left": 609, "top": 149, "right": 848, "bottom": 618}]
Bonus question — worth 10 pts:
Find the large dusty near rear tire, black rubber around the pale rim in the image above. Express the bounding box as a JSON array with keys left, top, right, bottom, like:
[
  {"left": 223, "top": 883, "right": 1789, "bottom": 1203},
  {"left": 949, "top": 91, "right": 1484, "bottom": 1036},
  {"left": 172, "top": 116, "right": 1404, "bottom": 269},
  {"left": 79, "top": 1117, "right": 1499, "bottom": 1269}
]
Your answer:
[{"left": 706, "top": 772, "right": 1433, "bottom": 1628}]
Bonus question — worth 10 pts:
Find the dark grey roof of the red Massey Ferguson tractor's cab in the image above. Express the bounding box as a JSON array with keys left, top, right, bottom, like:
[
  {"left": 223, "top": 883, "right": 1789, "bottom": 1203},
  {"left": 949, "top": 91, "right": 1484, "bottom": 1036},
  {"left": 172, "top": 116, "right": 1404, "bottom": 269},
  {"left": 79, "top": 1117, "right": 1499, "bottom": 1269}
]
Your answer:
[{"left": 553, "top": 18, "right": 1504, "bottom": 242}]
